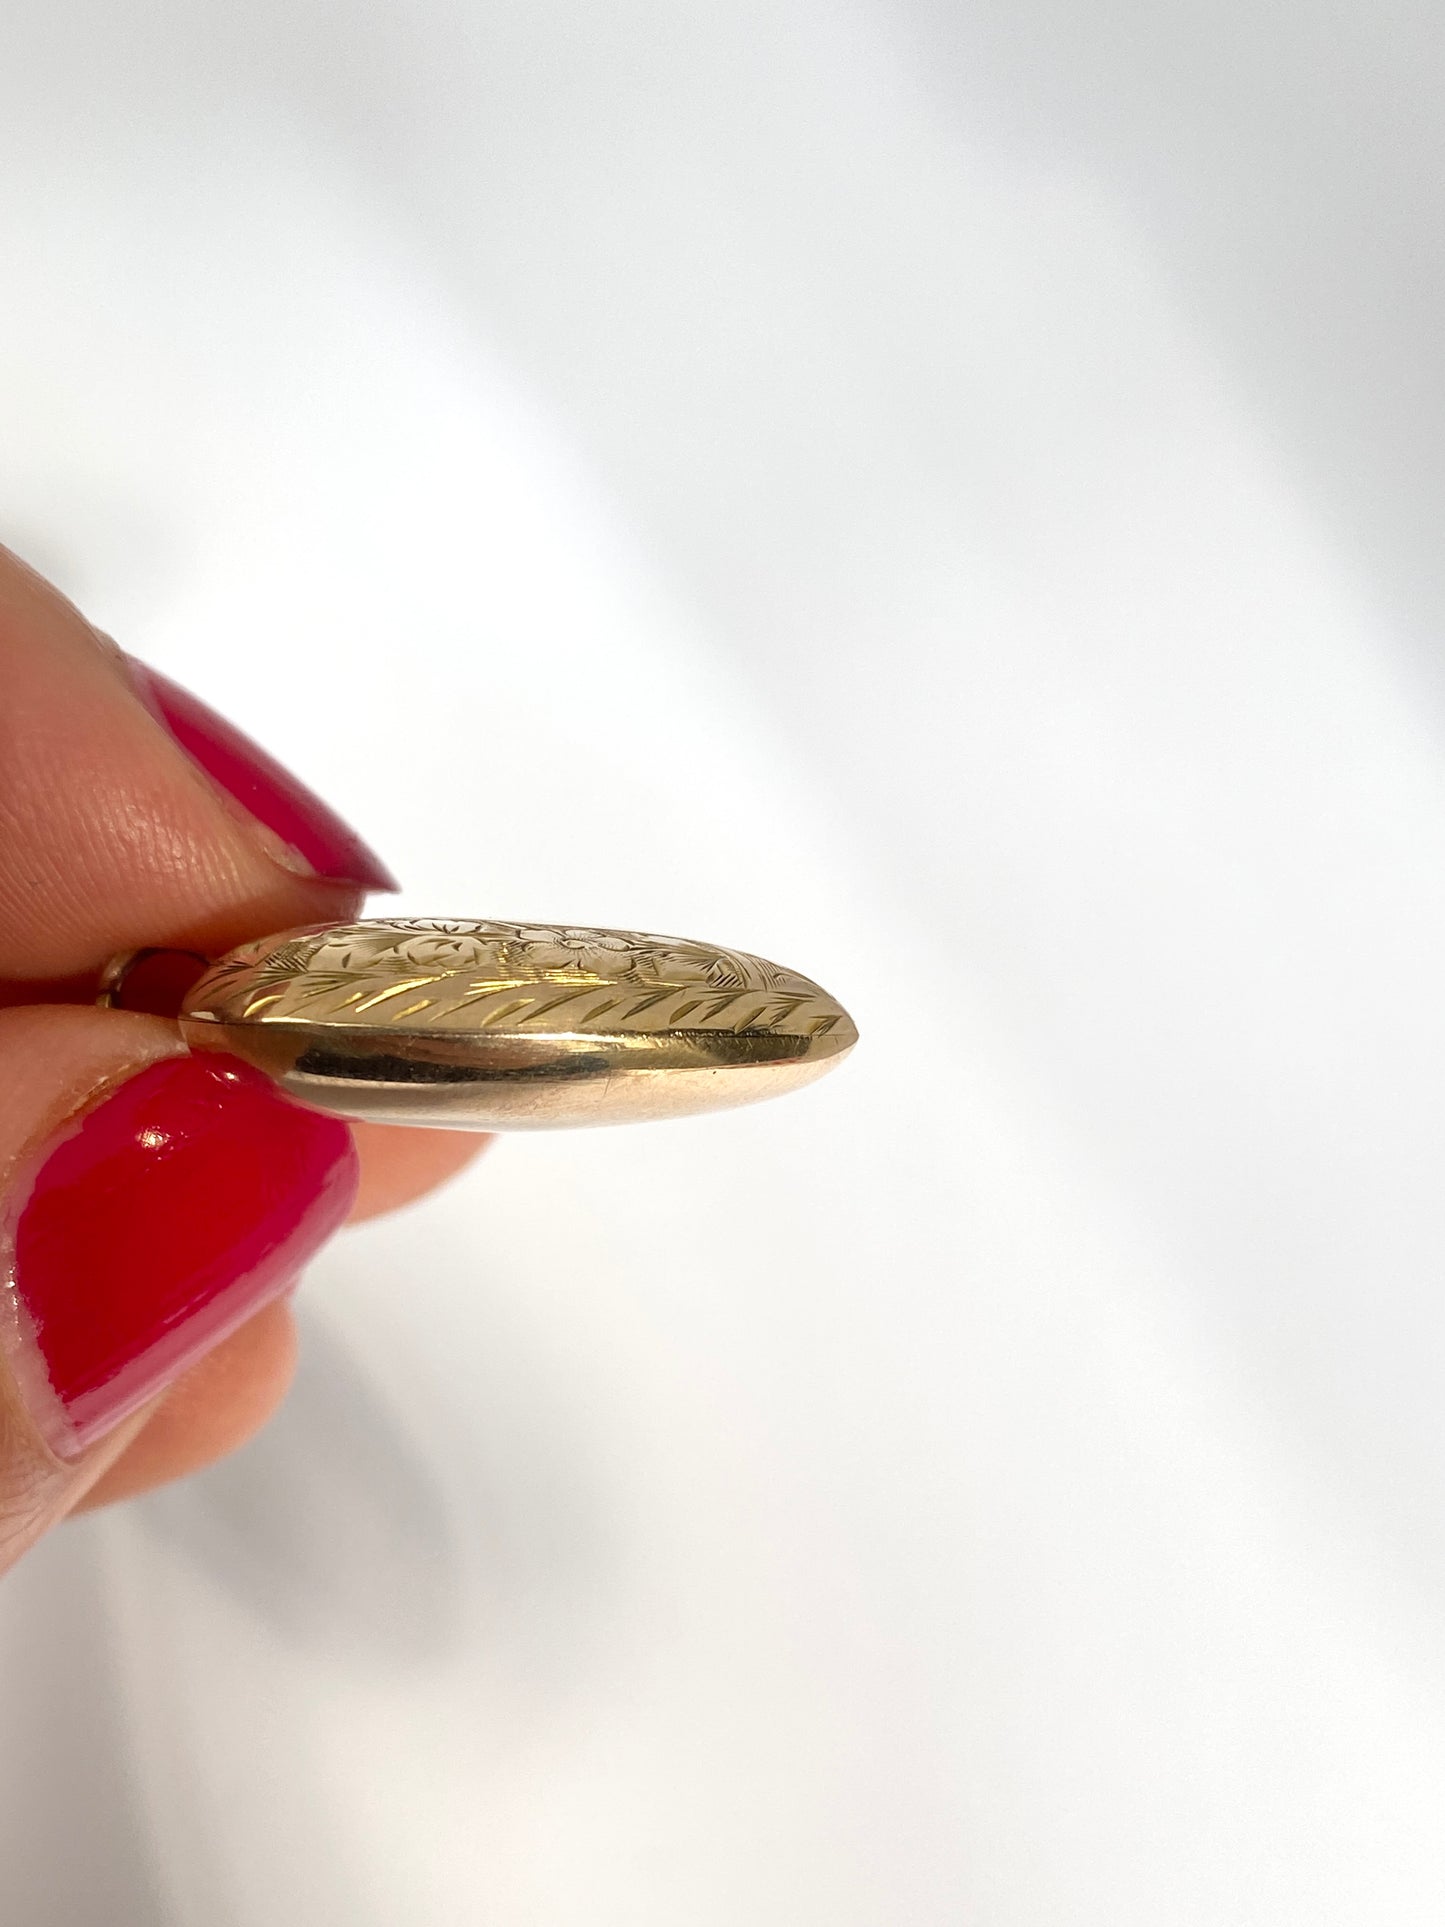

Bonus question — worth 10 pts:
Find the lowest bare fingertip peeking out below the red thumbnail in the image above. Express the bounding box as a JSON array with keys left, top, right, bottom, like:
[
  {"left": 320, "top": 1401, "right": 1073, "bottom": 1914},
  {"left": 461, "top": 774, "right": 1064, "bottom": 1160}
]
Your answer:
[{"left": 73, "top": 1299, "right": 297, "bottom": 1513}]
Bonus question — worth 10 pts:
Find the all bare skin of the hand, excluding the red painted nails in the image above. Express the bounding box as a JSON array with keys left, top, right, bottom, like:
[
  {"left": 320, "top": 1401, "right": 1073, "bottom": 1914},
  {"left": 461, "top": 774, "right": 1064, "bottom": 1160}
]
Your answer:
[{"left": 0, "top": 549, "right": 497, "bottom": 1547}]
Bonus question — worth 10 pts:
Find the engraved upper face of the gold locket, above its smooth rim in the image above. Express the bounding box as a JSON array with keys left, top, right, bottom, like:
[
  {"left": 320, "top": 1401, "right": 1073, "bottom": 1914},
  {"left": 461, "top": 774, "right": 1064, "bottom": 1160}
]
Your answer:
[{"left": 189, "top": 919, "right": 852, "bottom": 1048}]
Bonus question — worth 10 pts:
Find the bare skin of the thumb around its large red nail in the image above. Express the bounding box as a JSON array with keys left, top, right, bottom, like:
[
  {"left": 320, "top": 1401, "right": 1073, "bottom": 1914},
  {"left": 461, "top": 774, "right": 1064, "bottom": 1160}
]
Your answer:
[{"left": 0, "top": 1008, "right": 181, "bottom": 1569}]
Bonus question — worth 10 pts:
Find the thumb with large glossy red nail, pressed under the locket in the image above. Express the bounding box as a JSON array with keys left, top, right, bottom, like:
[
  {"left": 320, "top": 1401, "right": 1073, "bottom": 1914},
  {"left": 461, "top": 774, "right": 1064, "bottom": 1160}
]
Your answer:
[{"left": 0, "top": 1006, "right": 356, "bottom": 1567}]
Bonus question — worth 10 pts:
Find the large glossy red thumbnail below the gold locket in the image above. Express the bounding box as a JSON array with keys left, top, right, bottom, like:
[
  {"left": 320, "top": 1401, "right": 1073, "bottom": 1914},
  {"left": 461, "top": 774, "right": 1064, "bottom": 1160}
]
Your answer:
[{"left": 0, "top": 1058, "right": 358, "bottom": 1457}]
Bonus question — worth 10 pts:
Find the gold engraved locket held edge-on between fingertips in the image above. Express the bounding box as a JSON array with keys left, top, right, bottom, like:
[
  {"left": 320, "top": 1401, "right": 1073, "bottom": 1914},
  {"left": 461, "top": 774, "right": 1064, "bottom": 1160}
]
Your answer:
[{"left": 100, "top": 917, "right": 857, "bottom": 1131}]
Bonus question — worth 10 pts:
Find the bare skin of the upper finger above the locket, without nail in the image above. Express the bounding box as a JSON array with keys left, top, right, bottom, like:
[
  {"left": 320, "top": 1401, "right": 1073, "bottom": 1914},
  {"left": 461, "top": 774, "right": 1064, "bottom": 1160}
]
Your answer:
[{"left": 0, "top": 549, "right": 360, "bottom": 983}]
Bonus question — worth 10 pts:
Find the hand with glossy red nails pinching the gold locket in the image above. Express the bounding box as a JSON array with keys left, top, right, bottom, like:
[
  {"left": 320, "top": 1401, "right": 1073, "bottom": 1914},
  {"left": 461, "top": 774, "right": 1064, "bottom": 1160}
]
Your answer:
[{"left": 0, "top": 549, "right": 484, "bottom": 1567}]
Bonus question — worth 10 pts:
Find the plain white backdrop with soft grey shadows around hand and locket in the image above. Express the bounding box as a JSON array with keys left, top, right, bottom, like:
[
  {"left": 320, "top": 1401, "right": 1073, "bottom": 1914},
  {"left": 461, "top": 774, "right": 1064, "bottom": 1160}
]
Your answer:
[{"left": 0, "top": 0, "right": 1445, "bottom": 1927}]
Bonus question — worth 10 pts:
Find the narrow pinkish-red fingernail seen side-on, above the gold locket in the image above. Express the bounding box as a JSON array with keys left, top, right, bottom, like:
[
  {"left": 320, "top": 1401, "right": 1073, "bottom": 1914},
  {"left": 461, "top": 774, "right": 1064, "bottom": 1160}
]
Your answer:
[{"left": 125, "top": 655, "right": 401, "bottom": 890}]
